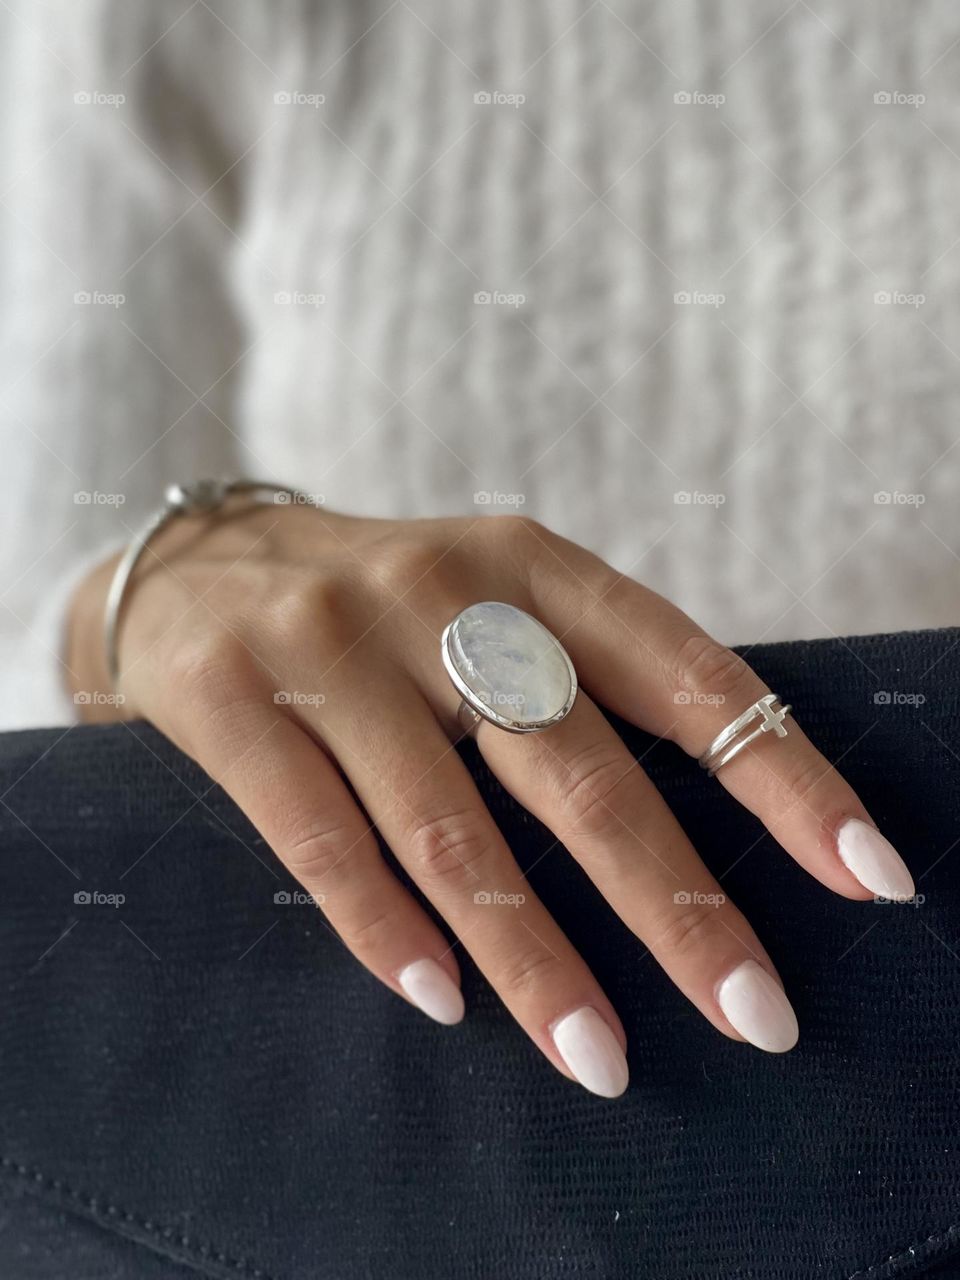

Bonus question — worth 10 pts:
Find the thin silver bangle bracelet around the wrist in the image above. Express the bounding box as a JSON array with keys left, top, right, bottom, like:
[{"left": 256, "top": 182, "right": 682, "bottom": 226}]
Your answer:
[{"left": 104, "top": 480, "right": 317, "bottom": 689}]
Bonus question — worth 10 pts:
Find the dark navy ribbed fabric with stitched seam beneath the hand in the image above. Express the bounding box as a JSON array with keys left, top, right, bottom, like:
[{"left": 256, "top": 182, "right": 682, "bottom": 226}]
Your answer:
[{"left": 0, "top": 631, "right": 960, "bottom": 1280}]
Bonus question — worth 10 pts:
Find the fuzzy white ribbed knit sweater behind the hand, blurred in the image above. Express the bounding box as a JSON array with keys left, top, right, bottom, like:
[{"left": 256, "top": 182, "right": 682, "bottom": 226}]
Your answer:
[{"left": 0, "top": 0, "right": 960, "bottom": 727}]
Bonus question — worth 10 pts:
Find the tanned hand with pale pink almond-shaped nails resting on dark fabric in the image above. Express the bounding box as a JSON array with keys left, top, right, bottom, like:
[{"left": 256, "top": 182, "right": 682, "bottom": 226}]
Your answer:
[{"left": 68, "top": 500, "right": 913, "bottom": 1097}]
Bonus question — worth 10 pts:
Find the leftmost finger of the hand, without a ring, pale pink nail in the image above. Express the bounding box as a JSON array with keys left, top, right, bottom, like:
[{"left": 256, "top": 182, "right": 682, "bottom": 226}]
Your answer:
[{"left": 183, "top": 701, "right": 463, "bottom": 1025}]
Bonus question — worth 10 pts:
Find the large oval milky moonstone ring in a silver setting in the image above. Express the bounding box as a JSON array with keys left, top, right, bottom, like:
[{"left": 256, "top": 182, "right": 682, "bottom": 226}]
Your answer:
[{"left": 440, "top": 600, "right": 577, "bottom": 733}]
